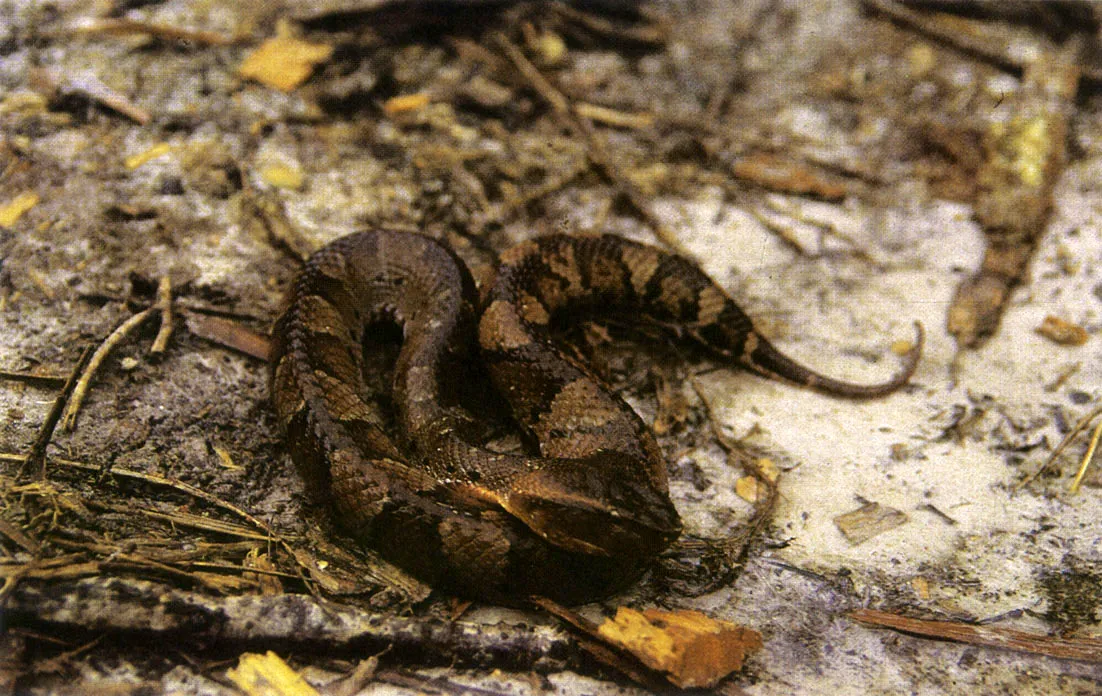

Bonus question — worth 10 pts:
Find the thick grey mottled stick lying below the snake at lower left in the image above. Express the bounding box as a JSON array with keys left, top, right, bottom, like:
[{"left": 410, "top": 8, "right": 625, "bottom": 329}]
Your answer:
[{"left": 3, "top": 577, "right": 585, "bottom": 672}]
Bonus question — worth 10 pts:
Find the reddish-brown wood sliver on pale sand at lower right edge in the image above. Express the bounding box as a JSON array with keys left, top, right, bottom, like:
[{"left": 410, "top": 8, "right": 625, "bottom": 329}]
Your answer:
[{"left": 847, "top": 609, "right": 1102, "bottom": 662}]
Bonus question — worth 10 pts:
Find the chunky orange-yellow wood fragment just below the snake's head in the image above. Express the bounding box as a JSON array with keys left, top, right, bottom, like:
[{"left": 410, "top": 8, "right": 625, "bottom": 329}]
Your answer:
[{"left": 597, "top": 607, "right": 761, "bottom": 688}]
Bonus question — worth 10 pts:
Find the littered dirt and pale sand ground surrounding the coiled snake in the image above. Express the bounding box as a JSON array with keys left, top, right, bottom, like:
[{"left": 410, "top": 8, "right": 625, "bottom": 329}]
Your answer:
[{"left": 0, "top": 0, "right": 1102, "bottom": 695}]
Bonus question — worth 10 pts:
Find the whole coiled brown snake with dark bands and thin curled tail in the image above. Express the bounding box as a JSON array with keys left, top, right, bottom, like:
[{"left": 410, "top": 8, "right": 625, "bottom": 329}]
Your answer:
[{"left": 271, "top": 229, "right": 921, "bottom": 602}]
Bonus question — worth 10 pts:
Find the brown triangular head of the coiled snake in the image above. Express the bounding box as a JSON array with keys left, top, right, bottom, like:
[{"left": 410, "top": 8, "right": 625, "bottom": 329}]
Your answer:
[{"left": 504, "top": 450, "right": 681, "bottom": 557}]
